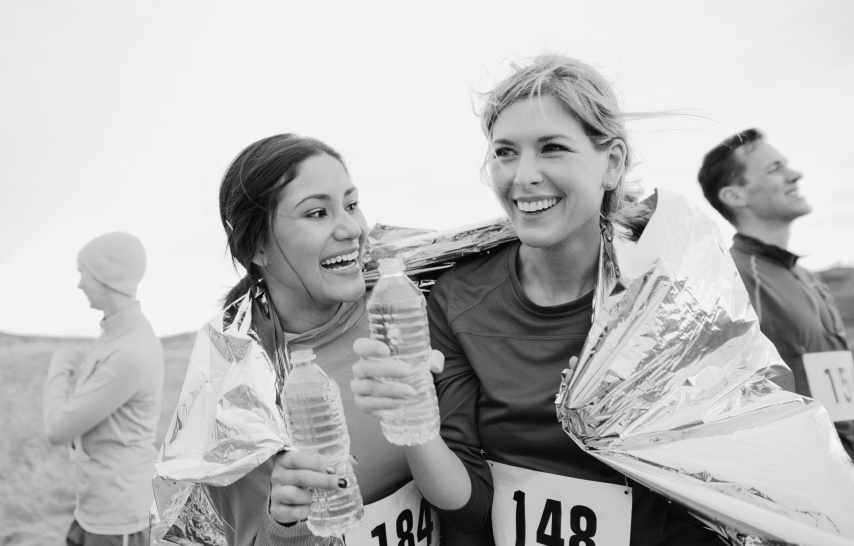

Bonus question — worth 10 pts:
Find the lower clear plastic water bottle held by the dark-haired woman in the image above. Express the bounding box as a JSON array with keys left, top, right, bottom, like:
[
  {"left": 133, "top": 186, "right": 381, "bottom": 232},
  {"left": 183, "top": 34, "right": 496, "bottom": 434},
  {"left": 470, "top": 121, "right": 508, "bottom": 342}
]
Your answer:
[{"left": 282, "top": 348, "right": 365, "bottom": 537}]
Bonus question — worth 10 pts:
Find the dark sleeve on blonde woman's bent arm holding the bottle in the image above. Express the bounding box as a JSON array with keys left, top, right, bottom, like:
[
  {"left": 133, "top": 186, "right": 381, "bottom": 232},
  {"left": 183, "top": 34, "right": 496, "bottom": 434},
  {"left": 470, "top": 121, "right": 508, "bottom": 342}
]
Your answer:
[{"left": 427, "top": 269, "right": 493, "bottom": 533}]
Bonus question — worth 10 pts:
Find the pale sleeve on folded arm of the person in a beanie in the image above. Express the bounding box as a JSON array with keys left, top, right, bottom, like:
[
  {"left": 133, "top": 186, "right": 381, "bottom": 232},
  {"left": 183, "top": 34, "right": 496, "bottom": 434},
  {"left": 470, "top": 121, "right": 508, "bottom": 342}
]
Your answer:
[{"left": 44, "top": 350, "right": 146, "bottom": 444}]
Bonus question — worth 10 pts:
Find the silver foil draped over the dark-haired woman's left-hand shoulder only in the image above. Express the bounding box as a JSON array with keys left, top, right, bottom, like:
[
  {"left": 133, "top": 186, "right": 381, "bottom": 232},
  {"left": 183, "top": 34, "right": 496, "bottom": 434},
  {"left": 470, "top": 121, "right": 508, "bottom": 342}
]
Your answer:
[{"left": 150, "top": 287, "right": 290, "bottom": 546}]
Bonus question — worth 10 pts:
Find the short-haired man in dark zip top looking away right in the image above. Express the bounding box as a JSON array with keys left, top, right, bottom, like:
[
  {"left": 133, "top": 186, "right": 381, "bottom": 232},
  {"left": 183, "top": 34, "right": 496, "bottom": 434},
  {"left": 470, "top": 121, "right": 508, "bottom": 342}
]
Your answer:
[{"left": 698, "top": 129, "right": 854, "bottom": 457}]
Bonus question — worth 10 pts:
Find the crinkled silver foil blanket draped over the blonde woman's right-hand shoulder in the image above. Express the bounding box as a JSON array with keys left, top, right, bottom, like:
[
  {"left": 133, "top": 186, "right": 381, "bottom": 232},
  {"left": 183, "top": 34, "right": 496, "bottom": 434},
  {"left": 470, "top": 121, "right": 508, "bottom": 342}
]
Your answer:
[{"left": 557, "top": 192, "right": 854, "bottom": 546}]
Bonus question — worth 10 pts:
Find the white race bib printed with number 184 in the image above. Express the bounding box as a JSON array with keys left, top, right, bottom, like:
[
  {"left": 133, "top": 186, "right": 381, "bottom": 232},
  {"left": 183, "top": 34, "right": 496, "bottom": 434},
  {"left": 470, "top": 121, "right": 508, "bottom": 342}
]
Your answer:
[{"left": 344, "top": 481, "right": 439, "bottom": 546}]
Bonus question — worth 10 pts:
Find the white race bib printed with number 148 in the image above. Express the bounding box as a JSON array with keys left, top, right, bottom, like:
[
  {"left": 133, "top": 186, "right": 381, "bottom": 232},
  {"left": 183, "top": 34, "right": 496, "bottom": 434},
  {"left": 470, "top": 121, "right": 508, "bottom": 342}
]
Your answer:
[{"left": 489, "top": 461, "right": 632, "bottom": 546}]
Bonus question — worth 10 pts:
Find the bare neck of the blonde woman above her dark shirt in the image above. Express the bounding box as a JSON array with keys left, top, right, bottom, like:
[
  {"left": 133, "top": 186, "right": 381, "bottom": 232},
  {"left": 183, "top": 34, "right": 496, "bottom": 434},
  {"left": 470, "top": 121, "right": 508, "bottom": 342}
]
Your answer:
[{"left": 516, "top": 219, "right": 601, "bottom": 306}]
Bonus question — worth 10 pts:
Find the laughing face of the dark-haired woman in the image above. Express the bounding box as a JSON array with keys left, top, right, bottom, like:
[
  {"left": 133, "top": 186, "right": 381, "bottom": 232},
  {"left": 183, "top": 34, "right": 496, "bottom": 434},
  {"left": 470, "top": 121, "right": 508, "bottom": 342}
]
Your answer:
[{"left": 256, "top": 154, "right": 368, "bottom": 307}]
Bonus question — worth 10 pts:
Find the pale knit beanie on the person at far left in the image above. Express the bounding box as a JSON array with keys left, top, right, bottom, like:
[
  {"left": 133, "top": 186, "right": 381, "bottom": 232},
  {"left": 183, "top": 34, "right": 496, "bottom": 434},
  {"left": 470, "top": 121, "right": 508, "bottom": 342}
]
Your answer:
[{"left": 77, "top": 231, "right": 145, "bottom": 297}]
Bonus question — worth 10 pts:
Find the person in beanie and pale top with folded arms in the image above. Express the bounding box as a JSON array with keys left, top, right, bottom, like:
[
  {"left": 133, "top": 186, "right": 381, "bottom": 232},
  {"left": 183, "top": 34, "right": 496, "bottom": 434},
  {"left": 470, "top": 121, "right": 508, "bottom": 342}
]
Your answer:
[{"left": 43, "top": 232, "right": 164, "bottom": 546}]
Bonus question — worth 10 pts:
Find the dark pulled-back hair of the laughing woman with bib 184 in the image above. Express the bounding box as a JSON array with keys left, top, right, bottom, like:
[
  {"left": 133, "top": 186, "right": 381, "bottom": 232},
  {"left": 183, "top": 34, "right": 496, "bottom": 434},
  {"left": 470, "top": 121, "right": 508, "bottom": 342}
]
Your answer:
[{"left": 219, "top": 133, "right": 347, "bottom": 307}]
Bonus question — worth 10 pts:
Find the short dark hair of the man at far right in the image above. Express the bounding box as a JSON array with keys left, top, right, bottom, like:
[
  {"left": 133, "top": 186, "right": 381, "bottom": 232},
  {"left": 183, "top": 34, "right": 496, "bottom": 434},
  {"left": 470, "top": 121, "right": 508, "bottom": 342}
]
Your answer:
[{"left": 697, "top": 129, "right": 765, "bottom": 224}]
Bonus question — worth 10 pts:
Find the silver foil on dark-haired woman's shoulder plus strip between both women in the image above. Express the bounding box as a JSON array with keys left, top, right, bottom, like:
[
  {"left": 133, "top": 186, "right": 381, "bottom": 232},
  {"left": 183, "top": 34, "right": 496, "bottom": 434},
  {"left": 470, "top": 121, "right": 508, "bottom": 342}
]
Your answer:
[{"left": 150, "top": 218, "right": 516, "bottom": 546}]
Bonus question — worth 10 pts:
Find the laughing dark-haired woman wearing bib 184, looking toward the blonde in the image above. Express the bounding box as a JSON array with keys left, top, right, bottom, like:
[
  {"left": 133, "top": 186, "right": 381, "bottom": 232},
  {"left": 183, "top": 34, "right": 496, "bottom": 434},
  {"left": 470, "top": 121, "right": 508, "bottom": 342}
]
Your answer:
[{"left": 209, "top": 134, "right": 441, "bottom": 546}]
